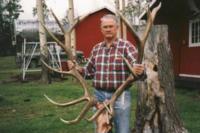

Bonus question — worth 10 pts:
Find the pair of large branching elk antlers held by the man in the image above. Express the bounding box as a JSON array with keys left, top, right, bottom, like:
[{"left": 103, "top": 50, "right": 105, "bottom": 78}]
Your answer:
[{"left": 42, "top": 1, "right": 161, "bottom": 124}]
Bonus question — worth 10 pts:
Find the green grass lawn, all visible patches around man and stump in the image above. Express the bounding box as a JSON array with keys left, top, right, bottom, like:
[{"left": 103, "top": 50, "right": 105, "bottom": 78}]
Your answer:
[{"left": 0, "top": 57, "right": 200, "bottom": 133}]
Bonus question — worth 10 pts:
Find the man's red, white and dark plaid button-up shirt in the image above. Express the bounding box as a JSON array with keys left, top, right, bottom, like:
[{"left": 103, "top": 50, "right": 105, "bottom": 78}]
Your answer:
[{"left": 84, "top": 39, "right": 137, "bottom": 89}]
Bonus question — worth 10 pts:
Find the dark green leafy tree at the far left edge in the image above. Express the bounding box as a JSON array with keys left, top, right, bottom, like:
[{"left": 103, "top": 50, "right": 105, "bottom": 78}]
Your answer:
[{"left": 0, "top": 0, "right": 23, "bottom": 55}]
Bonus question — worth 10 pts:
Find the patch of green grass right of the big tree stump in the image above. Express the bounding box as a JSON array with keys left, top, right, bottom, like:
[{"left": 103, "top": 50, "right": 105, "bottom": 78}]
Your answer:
[{"left": 176, "top": 88, "right": 200, "bottom": 133}]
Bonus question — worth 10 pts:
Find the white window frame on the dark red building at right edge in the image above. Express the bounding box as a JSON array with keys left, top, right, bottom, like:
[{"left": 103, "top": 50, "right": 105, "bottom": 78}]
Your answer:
[{"left": 189, "top": 18, "right": 200, "bottom": 47}]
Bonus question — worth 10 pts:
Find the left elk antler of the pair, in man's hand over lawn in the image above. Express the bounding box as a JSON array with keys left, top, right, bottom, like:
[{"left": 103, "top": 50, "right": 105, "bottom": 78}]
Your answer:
[{"left": 42, "top": 12, "right": 96, "bottom": 124}]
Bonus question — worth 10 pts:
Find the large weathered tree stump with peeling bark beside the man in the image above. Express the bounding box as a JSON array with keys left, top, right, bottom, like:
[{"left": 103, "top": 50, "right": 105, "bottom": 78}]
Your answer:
[{"left": 134, "top": 25, "right": 187, "bottom": 133}]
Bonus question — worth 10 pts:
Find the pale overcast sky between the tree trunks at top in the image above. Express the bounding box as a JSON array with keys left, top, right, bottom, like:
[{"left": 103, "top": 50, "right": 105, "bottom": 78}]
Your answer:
[{"left": 19, "top": 0, "right": 114, "bottom": 19}]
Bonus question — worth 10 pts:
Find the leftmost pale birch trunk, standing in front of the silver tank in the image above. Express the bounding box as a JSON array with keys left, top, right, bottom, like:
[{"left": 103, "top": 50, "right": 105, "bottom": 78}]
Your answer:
[{"left": 36, "top": 0, "right": 50, "bottom": 83}]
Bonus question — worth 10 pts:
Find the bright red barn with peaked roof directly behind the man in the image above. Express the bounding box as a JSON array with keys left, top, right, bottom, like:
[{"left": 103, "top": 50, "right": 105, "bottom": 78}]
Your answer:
[{"left": 76, "top": 7, "right": 138, "bottom": 57}]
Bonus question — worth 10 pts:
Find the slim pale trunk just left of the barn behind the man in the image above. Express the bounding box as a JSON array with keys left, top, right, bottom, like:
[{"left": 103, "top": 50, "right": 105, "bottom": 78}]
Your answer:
[{"left": 68, "top": 0, "right": 76, "bottom": 56}]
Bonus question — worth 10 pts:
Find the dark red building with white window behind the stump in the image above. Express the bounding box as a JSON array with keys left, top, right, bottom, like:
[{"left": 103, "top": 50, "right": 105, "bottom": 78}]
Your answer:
[{"left": 142, "top": 0, "right": 200, "bottom": 88}]
